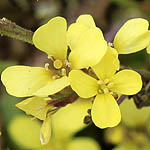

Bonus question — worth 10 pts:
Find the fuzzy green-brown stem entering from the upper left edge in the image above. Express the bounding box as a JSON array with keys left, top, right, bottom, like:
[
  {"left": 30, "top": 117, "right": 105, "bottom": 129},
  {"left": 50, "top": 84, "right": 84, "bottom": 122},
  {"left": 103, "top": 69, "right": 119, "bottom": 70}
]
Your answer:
[{"left": 0, "top": 18, "right": 33, "bottom": 44}]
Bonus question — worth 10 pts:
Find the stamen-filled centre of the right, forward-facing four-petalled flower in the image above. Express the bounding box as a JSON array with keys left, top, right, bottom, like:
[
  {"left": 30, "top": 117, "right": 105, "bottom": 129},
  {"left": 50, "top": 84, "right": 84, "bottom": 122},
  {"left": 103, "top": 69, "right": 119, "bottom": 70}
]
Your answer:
[{"left": 97, "top": 79, "right": 114, "bottom": 94}]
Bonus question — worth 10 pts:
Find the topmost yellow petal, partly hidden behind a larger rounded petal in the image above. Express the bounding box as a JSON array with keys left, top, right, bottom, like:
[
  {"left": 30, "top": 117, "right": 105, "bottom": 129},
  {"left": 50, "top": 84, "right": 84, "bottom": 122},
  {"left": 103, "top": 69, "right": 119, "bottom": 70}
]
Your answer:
[{"left": 67, "top": 15, "right": 96, "bottom": 50}]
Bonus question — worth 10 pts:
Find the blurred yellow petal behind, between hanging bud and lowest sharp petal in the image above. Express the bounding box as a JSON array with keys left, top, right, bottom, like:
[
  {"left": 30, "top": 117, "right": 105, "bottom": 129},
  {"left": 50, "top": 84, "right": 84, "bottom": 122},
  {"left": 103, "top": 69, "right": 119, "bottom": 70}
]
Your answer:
[{"left": 52, "top": 98, "right": 92, "bottom": 138}]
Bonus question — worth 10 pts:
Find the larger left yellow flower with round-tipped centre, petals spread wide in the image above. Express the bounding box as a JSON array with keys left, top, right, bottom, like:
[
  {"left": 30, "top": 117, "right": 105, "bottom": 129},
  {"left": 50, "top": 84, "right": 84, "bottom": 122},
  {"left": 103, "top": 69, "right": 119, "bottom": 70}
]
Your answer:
[{"left": 1, "top": 15, "right": 107, "bottom": 97}]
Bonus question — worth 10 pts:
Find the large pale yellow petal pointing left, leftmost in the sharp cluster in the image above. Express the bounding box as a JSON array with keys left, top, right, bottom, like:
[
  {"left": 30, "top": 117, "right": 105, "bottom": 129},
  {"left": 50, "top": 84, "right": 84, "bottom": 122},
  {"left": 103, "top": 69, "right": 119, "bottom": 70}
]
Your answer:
[{"left": 1, "top": 66, "right": 53, "bottom": 97}]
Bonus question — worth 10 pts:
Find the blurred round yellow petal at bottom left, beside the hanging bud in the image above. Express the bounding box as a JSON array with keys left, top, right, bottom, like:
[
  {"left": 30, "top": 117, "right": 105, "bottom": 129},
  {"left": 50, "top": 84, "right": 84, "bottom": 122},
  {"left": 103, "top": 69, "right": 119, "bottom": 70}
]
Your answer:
[{"left": 7, "top": 115, "right": 42, "bottom": 149}]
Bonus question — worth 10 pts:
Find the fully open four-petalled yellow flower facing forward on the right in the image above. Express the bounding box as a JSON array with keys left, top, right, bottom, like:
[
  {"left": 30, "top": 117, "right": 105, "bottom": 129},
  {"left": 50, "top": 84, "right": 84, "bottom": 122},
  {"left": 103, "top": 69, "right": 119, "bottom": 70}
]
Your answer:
[{"left": 69, "top": 47, "right": 142, "bottom": 128}]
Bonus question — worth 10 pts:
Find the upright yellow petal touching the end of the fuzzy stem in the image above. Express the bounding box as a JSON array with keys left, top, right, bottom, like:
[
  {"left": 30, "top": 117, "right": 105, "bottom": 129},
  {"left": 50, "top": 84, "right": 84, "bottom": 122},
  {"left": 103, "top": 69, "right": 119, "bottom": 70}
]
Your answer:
[{"left": 33, "top": 17, "right": 67, "bottom": 60}]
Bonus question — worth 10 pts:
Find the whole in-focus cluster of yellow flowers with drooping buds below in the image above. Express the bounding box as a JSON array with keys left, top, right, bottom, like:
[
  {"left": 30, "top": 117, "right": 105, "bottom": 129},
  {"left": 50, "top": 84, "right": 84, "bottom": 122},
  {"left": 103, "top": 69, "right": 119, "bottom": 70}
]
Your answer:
[{"left": 1, "top": 15, "right": 150, "bottom": 144}]
